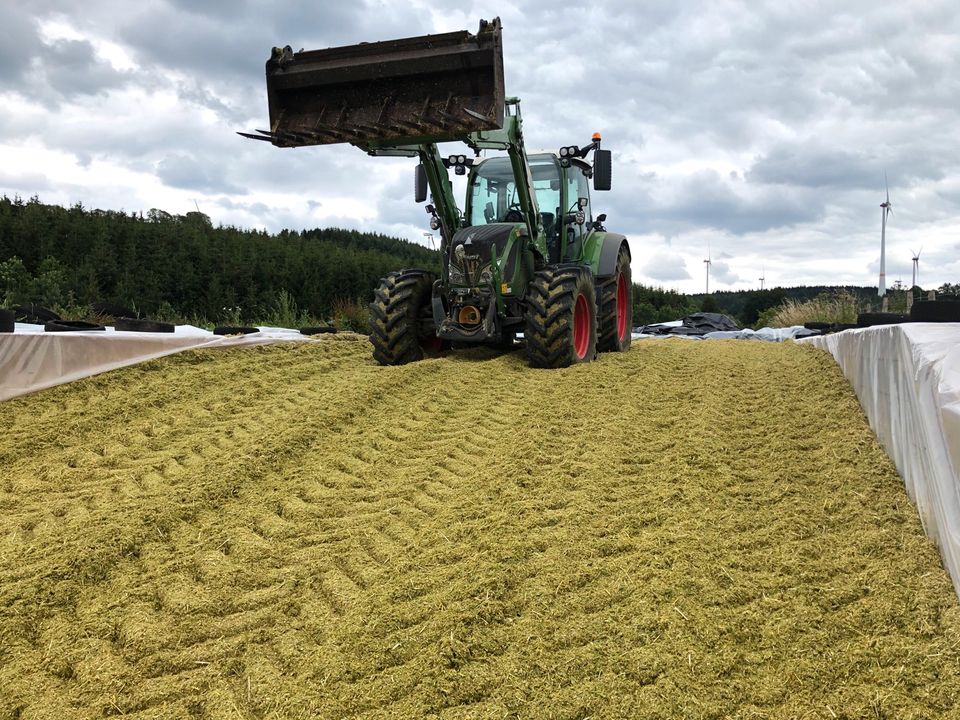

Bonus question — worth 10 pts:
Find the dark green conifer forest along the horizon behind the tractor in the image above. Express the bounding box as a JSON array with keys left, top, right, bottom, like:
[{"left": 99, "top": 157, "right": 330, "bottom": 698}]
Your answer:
[{"left": 0, "top": 196, "right": 952, "bottom": 329}]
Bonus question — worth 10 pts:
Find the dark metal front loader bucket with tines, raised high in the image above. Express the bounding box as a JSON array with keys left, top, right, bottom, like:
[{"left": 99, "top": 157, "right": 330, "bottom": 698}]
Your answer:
[{"left": 258, "top": 18, "right": 504, "bottom": 148}]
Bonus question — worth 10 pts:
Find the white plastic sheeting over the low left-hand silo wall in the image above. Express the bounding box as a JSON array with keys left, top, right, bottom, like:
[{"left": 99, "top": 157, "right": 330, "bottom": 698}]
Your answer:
[{"left": 0, "top": 323, "right": 323, "bottom": 400}]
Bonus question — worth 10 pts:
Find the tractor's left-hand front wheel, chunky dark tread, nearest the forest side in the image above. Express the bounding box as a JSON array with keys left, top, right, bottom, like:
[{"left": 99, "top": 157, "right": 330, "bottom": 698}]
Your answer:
[{"left": 370, "top": 270, "right": 447, "bottom": 365}]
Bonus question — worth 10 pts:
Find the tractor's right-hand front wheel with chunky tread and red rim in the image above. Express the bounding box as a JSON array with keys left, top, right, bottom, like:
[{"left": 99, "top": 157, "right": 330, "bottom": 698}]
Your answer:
[{"left": 524, "top": 266, "right": 597, "bottom": 368}]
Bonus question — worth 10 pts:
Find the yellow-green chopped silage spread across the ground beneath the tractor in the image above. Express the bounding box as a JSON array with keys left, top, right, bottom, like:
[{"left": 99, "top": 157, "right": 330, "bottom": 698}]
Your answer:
[{"left": 0, "top": 338, "right": 960, "bottom": 719}]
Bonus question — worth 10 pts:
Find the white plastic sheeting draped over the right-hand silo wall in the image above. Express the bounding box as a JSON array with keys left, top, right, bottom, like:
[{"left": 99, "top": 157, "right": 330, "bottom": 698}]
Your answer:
[{"left": 799, "top": 323, "right": 960, "bottom": 595}]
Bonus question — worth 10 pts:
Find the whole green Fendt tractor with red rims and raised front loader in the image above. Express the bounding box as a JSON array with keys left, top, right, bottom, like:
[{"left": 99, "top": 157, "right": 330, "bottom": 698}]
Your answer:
[{"left": 241, "top": 18, "right": 632, "bottom": 368}]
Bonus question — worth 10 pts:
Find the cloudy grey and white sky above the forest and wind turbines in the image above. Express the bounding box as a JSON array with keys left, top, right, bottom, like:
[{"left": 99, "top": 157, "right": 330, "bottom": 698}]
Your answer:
[{"left": 0, "top": 0, "right": 960, "bottom": 292}]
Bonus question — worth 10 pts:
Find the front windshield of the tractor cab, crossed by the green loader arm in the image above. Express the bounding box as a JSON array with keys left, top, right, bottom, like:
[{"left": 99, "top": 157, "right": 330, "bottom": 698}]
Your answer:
[{"left": 468, "top": 154, "right": 560, "bottom": 225}]
